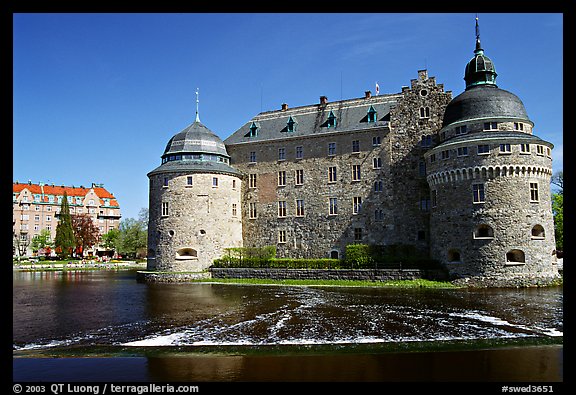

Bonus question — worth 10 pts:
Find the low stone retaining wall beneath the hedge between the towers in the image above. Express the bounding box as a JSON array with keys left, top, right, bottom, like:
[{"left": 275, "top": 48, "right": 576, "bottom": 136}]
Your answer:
[{"left": 209, "top": 268, "right": 447, "bottom": 281}]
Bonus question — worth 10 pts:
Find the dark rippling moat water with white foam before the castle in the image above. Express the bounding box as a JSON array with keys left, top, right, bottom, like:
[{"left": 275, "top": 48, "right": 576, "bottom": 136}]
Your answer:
[{"left": 12, "top": 270, "right": 563, "bottom": 382}]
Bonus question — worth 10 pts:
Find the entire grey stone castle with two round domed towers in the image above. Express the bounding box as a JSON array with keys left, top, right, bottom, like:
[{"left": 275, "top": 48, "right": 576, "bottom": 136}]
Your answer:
[{"left": 148, "top": 19, "right": 558, "bottom": 280}]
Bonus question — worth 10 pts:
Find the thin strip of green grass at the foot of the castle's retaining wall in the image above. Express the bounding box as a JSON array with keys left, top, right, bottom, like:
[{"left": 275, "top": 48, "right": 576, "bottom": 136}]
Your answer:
[{"left": 191, "top": 278, "right": 459, "bottom": 288}]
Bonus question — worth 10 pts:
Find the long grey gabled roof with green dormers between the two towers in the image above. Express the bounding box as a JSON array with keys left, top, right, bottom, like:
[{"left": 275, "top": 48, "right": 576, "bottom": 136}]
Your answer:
[{"left": 224, "top": 94, "right": 400, "bottom": 145}]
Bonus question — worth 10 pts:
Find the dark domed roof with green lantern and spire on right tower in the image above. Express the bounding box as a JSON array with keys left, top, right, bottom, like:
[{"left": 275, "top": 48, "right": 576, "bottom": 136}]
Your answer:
[{"left": 442, "top": 18, "right": 531, "bottom": 127}]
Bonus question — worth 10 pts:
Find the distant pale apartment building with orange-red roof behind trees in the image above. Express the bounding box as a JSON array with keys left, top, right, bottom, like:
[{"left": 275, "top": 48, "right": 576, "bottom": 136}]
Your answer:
[{"left": 12, "top": 181, "right": 121, "bottom": 255}]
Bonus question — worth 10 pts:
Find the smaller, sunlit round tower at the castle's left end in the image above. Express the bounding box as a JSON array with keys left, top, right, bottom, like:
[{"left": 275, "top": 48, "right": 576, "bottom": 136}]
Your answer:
[{"left": 148, "top": 93, "right": 242, "bottom": 272}]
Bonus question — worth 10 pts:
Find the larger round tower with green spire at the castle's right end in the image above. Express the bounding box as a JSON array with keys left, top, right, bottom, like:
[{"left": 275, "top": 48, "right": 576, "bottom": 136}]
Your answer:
[{"left": 425, "top": 19, "right": 558, "bottom": 284}]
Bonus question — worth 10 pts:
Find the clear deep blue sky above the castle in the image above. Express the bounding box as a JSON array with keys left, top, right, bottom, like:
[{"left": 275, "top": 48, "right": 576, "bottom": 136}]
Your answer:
[{"left": 13, "top": 13, "right": 563, "bottom": 218}]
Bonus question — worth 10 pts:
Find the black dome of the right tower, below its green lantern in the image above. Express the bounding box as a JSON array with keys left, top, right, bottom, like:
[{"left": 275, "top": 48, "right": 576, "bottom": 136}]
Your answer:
[{"left": 442, "top": 85, "right": 530, "bottom": 127}]
